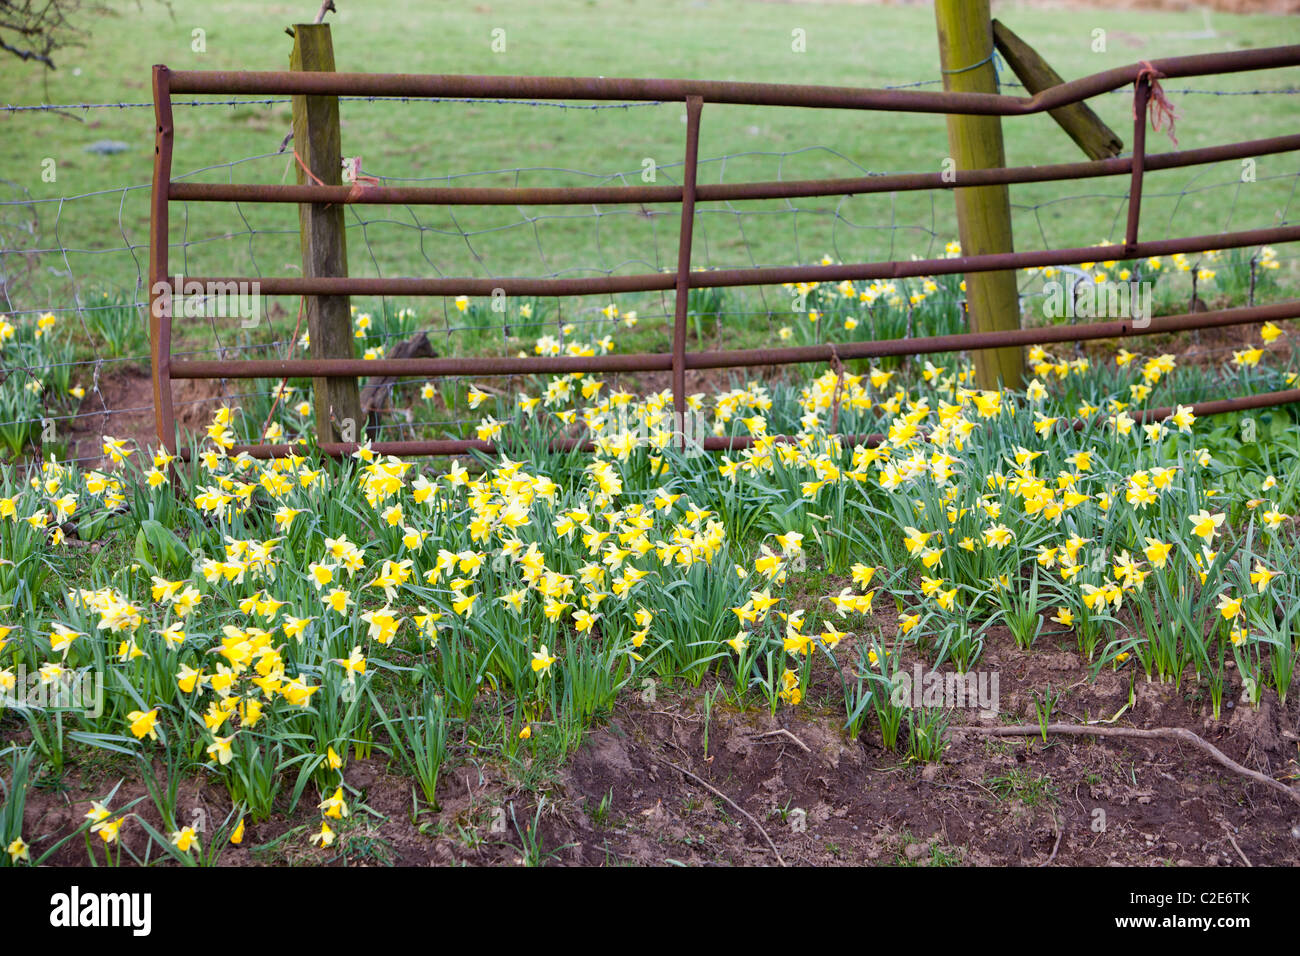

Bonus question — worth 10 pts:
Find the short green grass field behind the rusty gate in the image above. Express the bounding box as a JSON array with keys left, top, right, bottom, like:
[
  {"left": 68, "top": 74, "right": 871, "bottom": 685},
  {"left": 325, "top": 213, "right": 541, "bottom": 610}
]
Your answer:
[{"left": 0, "top": 0, "right": 1300, "bottom": 356}]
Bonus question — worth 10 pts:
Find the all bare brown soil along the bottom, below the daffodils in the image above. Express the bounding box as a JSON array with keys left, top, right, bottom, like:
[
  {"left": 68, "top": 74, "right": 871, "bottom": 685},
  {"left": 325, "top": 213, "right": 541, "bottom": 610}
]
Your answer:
[{"left": 17, "top": 622, "right": 1300, "bottom": 866}]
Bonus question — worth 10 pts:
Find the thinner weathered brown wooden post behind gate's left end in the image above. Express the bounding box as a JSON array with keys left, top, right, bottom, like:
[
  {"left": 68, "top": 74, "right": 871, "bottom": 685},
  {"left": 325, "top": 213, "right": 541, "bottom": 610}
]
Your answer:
[{"left": 289, "top": 23, "right": 365, "bottom": 442}]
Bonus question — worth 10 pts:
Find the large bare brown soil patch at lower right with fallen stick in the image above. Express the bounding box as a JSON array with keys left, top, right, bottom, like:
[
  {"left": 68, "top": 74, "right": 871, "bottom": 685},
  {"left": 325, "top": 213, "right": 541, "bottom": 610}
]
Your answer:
[{"left": 540, "top": 635, "right": 1300, "bottom": 866}]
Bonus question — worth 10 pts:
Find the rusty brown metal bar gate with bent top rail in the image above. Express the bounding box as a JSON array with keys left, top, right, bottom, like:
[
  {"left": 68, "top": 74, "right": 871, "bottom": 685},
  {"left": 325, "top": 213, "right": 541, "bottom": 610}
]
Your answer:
[{"left": 150, "top": 46, "right": 1300, "bottom": 457}]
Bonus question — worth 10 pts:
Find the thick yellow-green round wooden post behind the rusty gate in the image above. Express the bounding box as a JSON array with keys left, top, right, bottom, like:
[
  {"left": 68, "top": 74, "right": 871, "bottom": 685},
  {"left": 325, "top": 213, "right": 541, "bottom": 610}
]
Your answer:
[{"left": 935, "top": 0, "right": 1024, "bottom": 389}]
